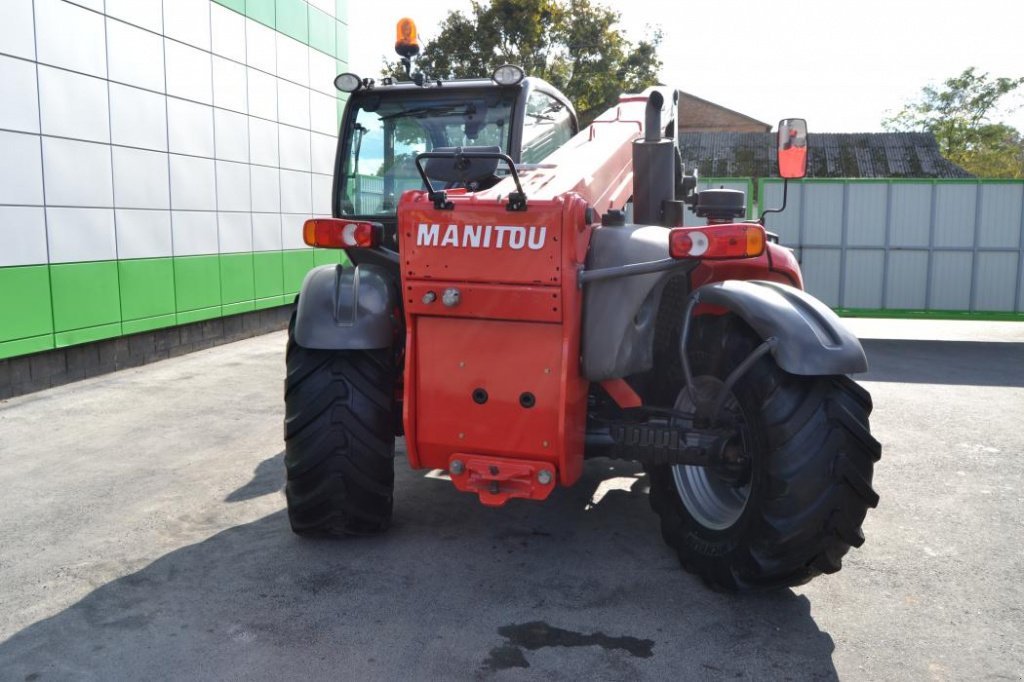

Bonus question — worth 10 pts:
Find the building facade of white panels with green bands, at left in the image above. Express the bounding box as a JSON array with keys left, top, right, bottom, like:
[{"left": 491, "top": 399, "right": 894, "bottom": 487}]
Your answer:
[{"left": 0, "top": 0, "right": 348, "bottom": 359}]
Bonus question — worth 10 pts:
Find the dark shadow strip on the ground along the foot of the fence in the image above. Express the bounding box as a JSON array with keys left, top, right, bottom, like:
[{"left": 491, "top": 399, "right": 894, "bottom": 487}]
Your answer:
[{"left": 855, "top": 339, "right": 1024, "bottom": 388}]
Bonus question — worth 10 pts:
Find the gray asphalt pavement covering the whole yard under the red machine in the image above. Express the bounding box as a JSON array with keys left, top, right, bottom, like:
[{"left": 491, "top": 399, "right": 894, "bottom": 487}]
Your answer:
[{"left": 0, "top": 321, "right": 1024, "bottom": 682}]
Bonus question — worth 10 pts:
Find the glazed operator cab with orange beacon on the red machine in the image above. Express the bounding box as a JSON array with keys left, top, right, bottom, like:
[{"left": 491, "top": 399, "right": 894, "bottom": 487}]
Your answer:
[{"left": 332, "top": 19, "right": 580, "bottom": 261}]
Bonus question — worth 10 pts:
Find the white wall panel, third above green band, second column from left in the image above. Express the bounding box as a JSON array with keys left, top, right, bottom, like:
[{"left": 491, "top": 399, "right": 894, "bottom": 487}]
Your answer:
[{"left": 39, "top": 67, "right": 111, "bottom": 142}]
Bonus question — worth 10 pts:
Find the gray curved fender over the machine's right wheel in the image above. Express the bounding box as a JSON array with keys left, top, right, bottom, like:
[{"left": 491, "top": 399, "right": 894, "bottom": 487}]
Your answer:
[{"left": 691, "top": 280, "right": 867, "bottom": 376}]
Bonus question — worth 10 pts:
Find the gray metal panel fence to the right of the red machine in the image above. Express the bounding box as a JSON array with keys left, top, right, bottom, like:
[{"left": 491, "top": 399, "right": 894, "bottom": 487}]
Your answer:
[{"left": 758, "top": 178, "right": 1024, "bottom": 313}]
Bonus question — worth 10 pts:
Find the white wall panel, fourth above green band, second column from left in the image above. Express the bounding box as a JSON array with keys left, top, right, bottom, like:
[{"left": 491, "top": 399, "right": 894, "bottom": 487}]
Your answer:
[{"left": 36, "top": 0, "right": 106, "bottom": 78}]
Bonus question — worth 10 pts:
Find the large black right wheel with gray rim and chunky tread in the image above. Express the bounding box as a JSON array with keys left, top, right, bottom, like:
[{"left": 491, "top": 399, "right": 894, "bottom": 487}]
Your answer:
[{"left": 649, "top": 315, "right": 881, "bottom": 591}]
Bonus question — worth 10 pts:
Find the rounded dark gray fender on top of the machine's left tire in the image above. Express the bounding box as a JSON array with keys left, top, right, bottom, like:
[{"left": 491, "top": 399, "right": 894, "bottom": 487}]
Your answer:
[{"left": 294, "top": 263, "right": 398, "bottom": 350}]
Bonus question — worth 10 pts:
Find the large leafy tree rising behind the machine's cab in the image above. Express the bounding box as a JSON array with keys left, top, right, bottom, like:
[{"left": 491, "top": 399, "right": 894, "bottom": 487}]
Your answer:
[{"left": 385, "top": 0, "right": 662, "bottom": 125}]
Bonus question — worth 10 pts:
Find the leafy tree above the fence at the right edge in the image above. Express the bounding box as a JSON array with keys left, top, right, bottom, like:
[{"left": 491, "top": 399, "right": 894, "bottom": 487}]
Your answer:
[{"left": 882, "top": 67, "right": 1024, "bottom": 178}]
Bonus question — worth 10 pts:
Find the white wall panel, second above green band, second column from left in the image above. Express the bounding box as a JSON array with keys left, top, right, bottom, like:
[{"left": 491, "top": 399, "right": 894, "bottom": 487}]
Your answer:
[{"left": 43, "top": 137, "right": 114, "bottom": 204}]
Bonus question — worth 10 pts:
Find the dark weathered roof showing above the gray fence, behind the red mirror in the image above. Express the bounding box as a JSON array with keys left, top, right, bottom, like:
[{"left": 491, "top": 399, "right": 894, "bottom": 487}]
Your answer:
[{"left": 679, "top": 132, "right": 973, "bottom": 177}]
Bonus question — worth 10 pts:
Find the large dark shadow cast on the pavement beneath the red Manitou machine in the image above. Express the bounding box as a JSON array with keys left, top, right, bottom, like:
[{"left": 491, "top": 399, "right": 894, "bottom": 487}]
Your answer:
[{"left": 0, "top": 455, "right": 837, "bottom": 680}]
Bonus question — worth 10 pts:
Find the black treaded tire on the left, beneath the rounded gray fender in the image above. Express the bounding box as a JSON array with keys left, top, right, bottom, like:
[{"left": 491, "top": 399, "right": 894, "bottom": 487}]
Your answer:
[{"left": 285, "top": 315, "right": 395, "bottom": 536}]
